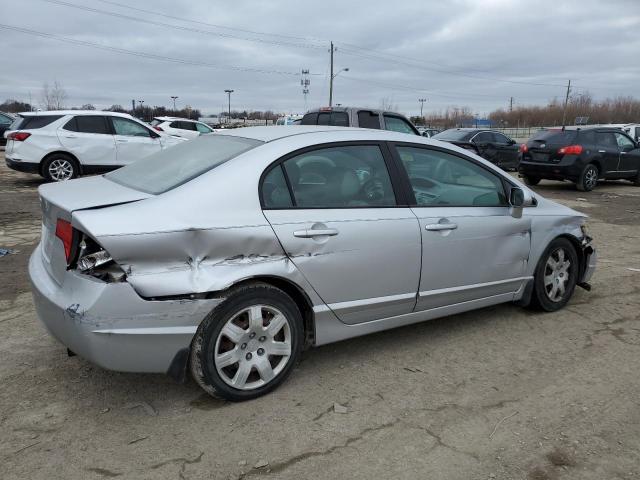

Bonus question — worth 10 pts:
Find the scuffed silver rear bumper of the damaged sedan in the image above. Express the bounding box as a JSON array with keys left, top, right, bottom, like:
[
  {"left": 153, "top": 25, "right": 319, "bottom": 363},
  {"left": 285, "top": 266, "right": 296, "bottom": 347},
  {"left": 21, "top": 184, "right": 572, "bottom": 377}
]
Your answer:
[{"left": 29, "top": 245, "right": 221, "bottom": 373}]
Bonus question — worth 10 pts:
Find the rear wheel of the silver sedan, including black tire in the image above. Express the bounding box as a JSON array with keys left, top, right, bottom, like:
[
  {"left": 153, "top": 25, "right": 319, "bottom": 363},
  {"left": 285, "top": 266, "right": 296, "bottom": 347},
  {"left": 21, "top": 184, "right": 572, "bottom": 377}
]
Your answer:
[{"left": 190, "top": 283, "right": 304, "bottom": 402}]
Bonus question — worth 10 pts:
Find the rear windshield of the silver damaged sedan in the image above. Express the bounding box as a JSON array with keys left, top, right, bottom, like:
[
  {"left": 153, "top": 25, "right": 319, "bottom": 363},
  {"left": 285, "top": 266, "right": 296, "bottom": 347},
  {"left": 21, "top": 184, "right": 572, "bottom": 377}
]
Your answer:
[{"left": 105, "top": 135, "right": 263, "bottom": 195}]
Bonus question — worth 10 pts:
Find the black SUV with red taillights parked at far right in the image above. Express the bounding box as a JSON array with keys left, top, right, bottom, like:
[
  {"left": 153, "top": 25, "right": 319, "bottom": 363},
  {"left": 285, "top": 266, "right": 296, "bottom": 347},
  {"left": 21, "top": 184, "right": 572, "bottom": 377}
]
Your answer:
[{"left": 518, "top": 127, "right": 640, "bottom": 192}]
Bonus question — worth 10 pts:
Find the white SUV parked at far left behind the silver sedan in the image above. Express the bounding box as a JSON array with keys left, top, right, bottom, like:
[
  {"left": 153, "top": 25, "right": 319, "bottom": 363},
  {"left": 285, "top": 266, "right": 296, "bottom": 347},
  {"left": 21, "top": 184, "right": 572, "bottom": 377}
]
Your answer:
[{"left": 5, "top": 110, "right": 184, "bottom": 181}]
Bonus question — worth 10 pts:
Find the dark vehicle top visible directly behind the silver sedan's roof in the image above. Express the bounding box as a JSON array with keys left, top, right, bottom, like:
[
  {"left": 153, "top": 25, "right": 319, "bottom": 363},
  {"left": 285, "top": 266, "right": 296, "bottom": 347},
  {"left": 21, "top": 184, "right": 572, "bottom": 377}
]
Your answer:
[{"left": 301, "top": 107, "right": 420, "bottom": 135}]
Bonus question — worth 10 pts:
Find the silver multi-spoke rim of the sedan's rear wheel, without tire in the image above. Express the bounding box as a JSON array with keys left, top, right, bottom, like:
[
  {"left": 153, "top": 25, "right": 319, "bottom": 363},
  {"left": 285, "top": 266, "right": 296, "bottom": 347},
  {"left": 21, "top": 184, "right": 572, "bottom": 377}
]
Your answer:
[{"left": 213, "top": 305, "right": 292, "bottom": 390}]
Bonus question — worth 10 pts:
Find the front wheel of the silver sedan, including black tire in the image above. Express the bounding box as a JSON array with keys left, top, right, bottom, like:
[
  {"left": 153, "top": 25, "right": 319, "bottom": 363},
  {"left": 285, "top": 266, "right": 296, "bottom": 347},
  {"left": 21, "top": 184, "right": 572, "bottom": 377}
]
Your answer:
[{"left": 531, "top": 238, "right": 580, "bottom": 312}]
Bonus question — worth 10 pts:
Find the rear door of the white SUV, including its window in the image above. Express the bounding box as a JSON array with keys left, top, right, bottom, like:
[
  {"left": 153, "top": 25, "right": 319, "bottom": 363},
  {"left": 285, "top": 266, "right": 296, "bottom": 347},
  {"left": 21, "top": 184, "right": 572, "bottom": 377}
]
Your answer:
[{"left": 58, "top": 115, "right": 116, "bottom": 167}]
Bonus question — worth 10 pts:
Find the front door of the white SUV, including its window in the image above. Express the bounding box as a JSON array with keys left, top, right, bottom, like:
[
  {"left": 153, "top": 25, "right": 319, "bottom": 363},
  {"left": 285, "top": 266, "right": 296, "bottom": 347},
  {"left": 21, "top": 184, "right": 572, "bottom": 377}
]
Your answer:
[{"left": 109, "top": 117, "right": 162, "bottom": 165}]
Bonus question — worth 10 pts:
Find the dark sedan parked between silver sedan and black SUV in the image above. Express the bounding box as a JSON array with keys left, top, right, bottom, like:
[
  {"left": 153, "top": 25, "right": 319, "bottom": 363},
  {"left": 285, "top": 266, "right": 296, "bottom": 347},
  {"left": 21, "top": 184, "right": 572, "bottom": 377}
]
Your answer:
[{"left": 432, "top": 128, "right": 518, "bottom": 170}]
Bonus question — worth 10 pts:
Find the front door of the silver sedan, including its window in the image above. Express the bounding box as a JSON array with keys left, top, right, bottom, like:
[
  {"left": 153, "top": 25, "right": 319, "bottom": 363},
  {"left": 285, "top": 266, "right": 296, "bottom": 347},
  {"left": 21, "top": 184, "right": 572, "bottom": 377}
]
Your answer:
[{"left": 396, "top": 145, "right": 531, "bottom": 310}]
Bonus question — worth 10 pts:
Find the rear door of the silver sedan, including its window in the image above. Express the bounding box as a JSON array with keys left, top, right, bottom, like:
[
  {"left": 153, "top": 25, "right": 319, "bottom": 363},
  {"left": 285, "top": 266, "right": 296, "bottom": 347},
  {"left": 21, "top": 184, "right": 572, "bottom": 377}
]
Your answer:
[{"left": 262, "top": 144, "right": 421, "bottom": 324}]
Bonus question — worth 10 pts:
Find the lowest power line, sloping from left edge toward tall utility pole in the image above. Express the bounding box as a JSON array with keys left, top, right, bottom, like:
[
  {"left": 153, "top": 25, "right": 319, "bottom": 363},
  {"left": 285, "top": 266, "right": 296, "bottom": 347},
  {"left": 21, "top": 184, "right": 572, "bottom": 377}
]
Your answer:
[{"left": 0, "top": 23, "right": 321, "bottom": 76}]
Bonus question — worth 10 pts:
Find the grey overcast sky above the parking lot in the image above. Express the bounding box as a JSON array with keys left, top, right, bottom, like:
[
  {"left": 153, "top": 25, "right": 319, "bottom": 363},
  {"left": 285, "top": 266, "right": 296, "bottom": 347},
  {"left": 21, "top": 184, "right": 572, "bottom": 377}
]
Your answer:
[{"left": 0, "top": 0, "right": 640, "bottom": 116}]
